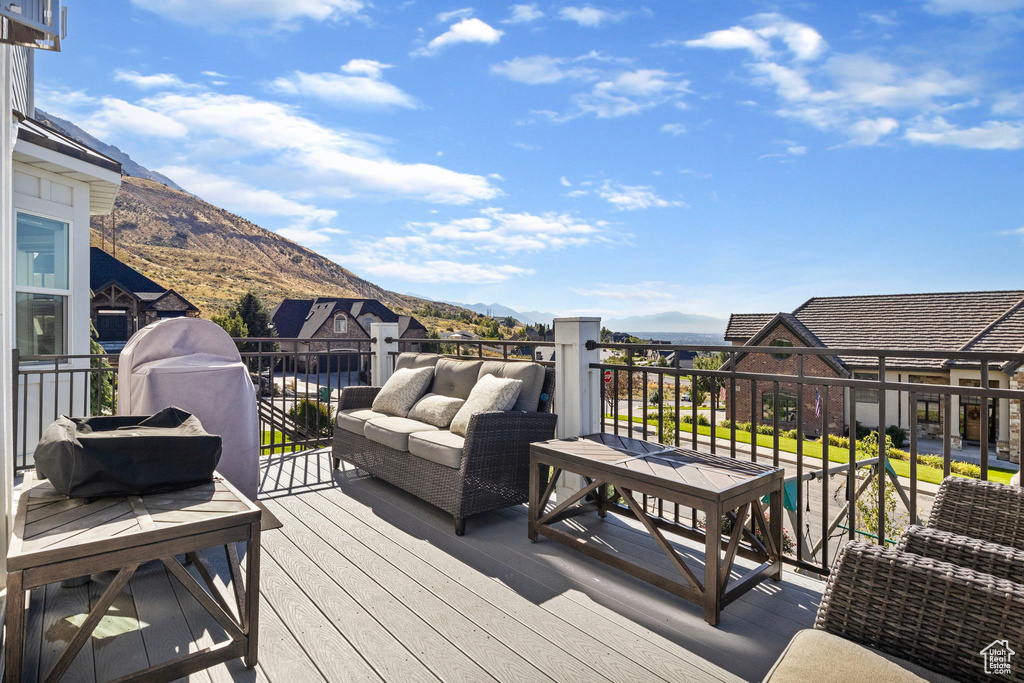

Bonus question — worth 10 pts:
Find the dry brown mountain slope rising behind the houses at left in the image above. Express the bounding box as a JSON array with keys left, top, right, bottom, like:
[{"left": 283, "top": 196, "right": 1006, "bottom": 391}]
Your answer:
[{"left": 92, "top": 176, "right": 461, "bottom": 317}]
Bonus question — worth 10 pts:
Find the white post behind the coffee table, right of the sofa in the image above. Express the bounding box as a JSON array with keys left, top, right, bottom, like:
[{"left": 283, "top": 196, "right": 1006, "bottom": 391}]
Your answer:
[{"left": 554, "top": 317, "right": 601, "bottom": 499}]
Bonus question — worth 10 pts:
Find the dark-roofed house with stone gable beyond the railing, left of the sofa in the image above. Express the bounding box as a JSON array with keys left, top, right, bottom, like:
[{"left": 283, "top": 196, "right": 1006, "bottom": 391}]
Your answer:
[{"left": 271, "top": 297, "right": 427, "bottom": 370}]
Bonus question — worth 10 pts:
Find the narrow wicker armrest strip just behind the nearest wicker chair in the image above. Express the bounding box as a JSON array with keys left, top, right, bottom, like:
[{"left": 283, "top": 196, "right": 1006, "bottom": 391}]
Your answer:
[{"left": 896, "top": 525, "right": 1024, "bottom": 583}]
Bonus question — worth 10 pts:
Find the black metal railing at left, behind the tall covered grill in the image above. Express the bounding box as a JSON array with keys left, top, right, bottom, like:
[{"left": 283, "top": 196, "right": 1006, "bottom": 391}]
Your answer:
[{"left": 11, "top": 337, "right": 375, "bottom": 470}]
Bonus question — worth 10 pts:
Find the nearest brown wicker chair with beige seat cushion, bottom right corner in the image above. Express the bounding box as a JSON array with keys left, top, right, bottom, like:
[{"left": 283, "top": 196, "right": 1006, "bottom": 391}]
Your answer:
[{"left": 765, "top": 542, "right": 1024, "bottom": 683}]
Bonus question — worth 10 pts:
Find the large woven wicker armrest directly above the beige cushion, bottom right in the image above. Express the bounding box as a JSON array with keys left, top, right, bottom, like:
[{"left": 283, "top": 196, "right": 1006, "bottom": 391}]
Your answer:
[{"left": 814, "top": 542, "right": 1024, "bottom": 681}]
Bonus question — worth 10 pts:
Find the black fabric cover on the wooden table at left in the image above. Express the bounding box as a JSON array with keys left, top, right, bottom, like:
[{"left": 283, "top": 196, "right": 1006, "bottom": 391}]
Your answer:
[{"left": 35, "top": 408, "right": 220, "bottom": 498}]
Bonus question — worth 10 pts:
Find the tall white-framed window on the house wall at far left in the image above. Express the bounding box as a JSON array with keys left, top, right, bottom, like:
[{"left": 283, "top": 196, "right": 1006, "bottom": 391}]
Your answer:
[{"left": 14, "top": 212, "right": 71, "bottom": 355}]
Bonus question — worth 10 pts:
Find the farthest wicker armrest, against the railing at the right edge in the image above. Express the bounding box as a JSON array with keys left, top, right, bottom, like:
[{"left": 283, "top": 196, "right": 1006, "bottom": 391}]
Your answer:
[{"left": 928, "top": 477, "right": 1024, "bottom": 550}]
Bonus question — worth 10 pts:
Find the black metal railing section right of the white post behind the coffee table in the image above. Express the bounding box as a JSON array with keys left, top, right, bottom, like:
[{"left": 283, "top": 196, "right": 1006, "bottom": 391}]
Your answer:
[{"left": 587, "top": 341, "right": 1024, "bottom": 573}]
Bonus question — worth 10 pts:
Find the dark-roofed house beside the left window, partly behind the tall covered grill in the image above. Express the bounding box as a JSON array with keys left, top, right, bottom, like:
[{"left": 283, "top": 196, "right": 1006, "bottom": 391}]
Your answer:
[{"left": 89, "top": 247, "right": 199, "bottom": 352}]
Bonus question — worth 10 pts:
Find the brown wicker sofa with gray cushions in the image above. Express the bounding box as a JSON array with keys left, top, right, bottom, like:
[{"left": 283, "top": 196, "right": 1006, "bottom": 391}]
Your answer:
[{"left": 332, "top": 353, "right": 558, "bottom": 536}]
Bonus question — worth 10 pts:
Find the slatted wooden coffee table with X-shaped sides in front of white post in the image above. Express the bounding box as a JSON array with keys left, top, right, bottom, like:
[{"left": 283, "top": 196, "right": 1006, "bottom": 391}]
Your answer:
[{"left": 529, "top": 434, "right": 784, "bottom": 626}]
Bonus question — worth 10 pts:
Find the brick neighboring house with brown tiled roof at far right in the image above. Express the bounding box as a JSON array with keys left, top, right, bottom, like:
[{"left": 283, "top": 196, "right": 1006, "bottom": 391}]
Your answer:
[{"left": 725, "top": 291, "right": 1024, "bottom": 461}]
